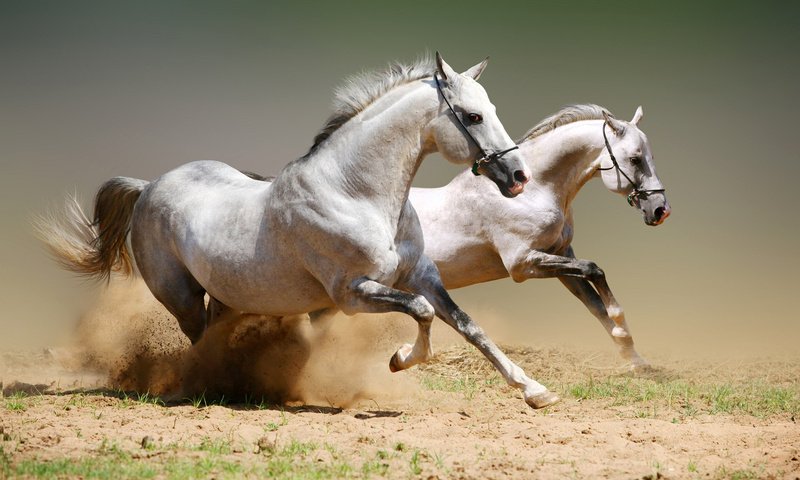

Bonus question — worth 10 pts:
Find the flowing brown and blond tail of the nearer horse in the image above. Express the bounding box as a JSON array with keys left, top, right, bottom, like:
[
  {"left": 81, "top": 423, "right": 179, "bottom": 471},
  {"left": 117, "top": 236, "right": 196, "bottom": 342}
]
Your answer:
[{"left": 33, "top": 177, "right": 148, "bottom": 280}]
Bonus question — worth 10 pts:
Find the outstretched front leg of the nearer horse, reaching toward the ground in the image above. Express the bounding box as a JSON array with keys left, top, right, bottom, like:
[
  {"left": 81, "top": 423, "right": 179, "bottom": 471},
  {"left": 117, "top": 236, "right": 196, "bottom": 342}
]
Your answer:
[{"left": 404, "top": 255, "right": 560, "bottom": 408}]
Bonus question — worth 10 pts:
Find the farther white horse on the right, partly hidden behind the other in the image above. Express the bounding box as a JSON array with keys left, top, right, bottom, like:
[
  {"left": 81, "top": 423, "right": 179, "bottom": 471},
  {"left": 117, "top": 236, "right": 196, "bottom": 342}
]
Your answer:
[{"left": 410, "top": 105, "right": 670, "bottom": 368}]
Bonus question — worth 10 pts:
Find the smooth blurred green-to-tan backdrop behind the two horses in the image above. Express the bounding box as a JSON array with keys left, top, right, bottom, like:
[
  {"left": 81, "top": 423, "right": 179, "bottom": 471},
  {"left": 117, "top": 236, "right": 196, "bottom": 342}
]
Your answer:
[{"left": 0, "top": 0, "right": 800, "bottom": 354}]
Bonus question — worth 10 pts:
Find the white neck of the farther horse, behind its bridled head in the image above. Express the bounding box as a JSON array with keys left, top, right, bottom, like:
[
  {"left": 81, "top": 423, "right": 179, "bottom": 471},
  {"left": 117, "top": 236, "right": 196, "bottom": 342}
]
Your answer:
[{"left": 520, "top": 120, "right": 604, "bottom": 208}]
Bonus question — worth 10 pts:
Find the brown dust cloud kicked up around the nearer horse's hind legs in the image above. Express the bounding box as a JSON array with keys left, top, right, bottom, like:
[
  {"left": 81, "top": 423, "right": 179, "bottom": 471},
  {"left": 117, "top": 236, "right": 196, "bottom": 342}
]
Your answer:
[{"left": 62, "top": 280, "right": 417, "bottom": 407}]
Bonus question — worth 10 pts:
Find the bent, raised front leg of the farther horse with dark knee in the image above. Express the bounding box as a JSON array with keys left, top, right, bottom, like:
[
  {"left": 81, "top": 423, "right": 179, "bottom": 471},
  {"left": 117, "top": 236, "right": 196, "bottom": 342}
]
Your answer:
[{"left": 506, "top": 247, "right": 630, "bottom": 338}]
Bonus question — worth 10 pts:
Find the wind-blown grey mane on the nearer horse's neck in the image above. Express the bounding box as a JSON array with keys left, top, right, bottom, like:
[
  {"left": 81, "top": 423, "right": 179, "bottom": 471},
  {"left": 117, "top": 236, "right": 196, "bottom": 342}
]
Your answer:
[{"left": 303, "top": 54, "right": 436, "bottom": 158}]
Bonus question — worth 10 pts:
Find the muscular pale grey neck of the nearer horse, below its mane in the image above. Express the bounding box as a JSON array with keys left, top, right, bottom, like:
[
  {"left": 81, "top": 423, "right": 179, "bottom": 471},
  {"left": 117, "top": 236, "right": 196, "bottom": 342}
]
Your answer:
[{"left": 310, "top": 81, "right": 438, "bottom": 216}]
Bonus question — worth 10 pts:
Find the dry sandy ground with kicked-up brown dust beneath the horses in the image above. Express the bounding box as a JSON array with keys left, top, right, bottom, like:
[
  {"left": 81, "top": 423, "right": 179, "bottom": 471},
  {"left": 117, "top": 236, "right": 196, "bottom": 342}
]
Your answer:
[{"left": 0, "top": 280, "right": 800, "bottom": 479}]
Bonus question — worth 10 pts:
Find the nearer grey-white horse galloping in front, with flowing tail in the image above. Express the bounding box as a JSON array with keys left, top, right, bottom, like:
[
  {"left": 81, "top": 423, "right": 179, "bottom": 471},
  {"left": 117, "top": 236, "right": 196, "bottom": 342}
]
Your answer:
[{"left": 40, "top": 53, "right": 558, "bottom": 408}]
